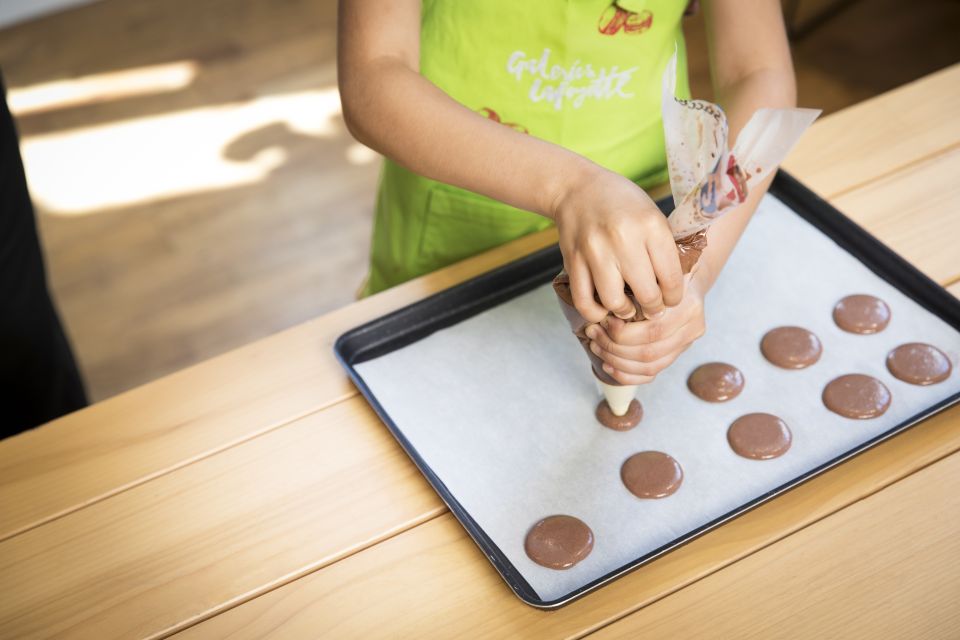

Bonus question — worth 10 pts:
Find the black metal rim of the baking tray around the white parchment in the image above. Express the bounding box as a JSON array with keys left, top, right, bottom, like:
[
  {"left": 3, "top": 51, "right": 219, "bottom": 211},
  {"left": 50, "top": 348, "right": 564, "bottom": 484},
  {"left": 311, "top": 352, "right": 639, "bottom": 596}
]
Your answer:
[{"left": 334, "top": 171, "right": 960, "bottom": 609}]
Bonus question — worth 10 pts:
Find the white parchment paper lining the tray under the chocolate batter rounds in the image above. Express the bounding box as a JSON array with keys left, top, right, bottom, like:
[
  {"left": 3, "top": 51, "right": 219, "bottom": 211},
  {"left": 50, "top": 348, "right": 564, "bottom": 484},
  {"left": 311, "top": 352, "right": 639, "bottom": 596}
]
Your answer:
[{"left": 356, "top": 196, "right": 960, "bottom": 600}]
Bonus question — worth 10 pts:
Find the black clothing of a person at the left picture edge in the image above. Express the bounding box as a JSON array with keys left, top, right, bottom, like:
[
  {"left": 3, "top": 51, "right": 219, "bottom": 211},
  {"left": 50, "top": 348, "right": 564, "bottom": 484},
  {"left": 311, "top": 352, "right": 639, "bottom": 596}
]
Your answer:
[{"left": 0, "top": 76, "right": 87, "bottom": 438}]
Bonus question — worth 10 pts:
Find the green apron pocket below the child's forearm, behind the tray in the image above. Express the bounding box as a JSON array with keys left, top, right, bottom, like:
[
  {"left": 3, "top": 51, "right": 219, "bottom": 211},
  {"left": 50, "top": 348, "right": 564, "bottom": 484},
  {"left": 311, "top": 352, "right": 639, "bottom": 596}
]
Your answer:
[{"left": 419, "top": 184, "right": 551, "bottom": 271}]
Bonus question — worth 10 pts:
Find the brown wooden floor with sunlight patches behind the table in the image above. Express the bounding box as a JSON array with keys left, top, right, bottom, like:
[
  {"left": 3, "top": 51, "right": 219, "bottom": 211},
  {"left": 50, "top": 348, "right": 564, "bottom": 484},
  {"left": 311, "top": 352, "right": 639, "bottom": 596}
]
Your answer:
[{"left": 0, "top": 0, "right": 960, "bottom": 399}]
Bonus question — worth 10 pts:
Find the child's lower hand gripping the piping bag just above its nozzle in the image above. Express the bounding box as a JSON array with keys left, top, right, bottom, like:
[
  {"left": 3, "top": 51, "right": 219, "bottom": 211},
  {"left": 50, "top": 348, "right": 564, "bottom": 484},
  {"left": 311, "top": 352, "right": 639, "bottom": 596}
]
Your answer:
[{"left": 587, "top": 276, "right": 706, "bottom": 384}]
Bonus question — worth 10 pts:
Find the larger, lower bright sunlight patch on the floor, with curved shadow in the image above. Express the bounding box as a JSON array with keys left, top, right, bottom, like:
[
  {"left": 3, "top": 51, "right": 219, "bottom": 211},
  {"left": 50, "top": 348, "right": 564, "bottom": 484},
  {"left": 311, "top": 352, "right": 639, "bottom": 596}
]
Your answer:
[{"left": 21, "top": 86, "right": 341, "bottom": 215}]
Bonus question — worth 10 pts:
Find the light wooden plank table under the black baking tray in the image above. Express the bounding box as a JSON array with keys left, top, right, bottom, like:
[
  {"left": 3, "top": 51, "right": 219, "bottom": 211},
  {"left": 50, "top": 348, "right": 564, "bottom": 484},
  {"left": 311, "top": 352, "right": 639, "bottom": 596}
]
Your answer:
[{"left": 0, "top": 65, "right": 960, "bottom": 638}]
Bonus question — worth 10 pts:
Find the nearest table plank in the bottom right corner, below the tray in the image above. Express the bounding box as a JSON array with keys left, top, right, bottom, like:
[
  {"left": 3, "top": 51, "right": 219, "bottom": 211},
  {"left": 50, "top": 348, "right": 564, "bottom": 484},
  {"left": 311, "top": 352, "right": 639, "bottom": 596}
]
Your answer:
[{"left": 591, "top": 453, "right": 960, "bottom": 640}]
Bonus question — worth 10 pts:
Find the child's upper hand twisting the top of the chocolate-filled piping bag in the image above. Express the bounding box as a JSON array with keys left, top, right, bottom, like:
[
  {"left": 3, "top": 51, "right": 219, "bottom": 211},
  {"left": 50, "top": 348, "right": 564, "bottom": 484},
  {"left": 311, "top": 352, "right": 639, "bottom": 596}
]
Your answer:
[{"left": 553, "top": 167, "right": 683, "bottom": 324}]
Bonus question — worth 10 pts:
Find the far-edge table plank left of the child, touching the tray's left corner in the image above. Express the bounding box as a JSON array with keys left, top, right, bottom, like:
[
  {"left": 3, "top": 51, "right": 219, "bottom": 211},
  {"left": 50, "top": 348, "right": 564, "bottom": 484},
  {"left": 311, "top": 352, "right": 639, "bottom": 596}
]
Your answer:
[{"left": 0, "top": 230, "right": 556, "bottom": 540}]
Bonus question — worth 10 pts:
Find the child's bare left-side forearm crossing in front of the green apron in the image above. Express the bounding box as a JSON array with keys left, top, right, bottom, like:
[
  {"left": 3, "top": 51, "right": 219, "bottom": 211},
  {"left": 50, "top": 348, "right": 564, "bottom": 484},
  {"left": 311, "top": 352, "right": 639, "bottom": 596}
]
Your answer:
[{"left": 340, "top": 58, "right": 599, "bottom": 218}]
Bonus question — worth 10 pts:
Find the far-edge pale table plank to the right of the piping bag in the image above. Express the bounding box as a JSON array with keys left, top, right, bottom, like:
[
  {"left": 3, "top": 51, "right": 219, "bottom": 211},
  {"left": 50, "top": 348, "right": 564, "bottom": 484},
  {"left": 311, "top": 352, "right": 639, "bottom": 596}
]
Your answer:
[{"left": 783, "top": 64, "right": 960, "bottom": 198}]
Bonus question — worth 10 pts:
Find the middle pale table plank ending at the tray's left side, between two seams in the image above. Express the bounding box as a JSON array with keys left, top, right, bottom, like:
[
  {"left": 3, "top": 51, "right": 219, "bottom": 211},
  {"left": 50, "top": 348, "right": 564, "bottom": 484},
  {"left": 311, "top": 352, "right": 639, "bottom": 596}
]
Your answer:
[{"left": 0, "top": 396, "right": 445, "bottom": 638}]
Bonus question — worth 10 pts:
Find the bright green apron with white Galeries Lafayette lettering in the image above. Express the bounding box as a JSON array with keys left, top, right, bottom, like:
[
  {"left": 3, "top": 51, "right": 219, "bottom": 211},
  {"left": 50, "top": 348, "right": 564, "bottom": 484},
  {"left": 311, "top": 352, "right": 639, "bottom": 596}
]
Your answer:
[{"left": 362, "top": 0, "right": 689, "bottom": 295}]
